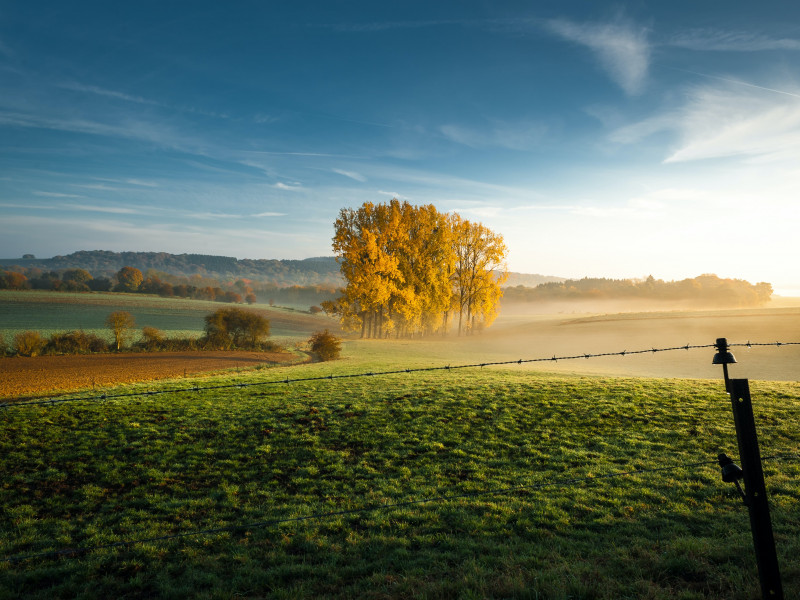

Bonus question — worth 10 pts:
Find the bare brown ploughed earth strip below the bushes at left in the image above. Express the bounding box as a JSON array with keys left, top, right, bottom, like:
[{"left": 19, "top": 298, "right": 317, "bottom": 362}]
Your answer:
[{"left": 0, "top": 351, "right": 297, "bottom": 398}]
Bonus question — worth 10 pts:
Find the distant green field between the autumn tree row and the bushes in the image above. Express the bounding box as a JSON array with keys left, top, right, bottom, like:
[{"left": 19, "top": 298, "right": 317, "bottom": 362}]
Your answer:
[{"left": 0, "top": 290, "right": 336, "bottom": 342}]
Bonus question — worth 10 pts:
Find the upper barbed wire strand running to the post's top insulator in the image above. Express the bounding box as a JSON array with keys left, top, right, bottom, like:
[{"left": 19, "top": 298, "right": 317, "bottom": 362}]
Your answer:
[{"left": 6, "top": 341, "right": 800, "bottom": 408}]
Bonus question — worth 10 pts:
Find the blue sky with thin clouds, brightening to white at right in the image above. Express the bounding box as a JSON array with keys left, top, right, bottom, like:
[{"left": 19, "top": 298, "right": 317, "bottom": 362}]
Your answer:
[{"left": 0, "top": 0, "right": 800, "bottom": 289}]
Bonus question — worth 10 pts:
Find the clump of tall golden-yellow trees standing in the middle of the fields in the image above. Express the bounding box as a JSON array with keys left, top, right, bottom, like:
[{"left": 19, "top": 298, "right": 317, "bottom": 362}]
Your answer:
[{"left": 322, "top": 199, "right": 506, "bottom": 338}]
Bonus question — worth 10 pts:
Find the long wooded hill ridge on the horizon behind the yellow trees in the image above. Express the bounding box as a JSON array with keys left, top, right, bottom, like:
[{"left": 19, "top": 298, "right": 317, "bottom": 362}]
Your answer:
[{"left": 0, "top": 250, "right": 564, "bottom": 287}]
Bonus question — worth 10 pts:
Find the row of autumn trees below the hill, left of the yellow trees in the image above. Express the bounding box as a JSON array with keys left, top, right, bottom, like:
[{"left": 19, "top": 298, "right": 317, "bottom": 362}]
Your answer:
[{"left": 0, "top": 266, "right": 339, "bottom": 306}]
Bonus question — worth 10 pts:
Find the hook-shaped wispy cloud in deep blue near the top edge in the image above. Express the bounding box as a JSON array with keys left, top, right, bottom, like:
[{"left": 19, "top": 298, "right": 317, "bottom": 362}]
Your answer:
[{"left": 547, "top": 17, "right": 650, "bottom": 94}]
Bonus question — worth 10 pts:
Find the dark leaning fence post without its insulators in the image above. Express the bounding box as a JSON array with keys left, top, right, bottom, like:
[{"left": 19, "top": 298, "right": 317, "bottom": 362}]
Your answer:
[{"left": 728, "top": 379, "right": 783, "bottom": 600}]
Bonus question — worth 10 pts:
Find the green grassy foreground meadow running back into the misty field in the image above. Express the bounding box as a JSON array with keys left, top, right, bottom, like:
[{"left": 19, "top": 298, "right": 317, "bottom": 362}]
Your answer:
[{"left": 0, "top": 297, "right": 800, "bottom": 600}]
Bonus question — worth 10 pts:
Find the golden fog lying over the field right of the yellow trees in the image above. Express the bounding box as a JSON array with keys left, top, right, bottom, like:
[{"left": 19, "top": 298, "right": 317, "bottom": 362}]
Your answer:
[{"left": 439, "top": 298, "right": 800, "bottom": 381}]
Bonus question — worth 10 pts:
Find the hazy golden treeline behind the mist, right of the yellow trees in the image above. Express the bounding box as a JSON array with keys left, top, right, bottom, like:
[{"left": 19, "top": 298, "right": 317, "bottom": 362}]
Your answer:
[{"left": 503, "top": 274, "right": 772, "bottom": 307}]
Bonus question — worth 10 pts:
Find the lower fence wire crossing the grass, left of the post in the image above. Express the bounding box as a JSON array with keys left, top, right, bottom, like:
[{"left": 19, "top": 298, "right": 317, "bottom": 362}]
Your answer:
[{"left": 0, "top": 459, "right": 717, "bottom": 563}]
